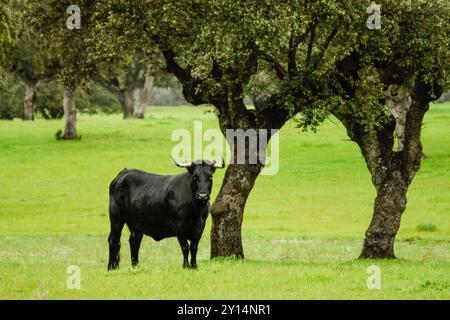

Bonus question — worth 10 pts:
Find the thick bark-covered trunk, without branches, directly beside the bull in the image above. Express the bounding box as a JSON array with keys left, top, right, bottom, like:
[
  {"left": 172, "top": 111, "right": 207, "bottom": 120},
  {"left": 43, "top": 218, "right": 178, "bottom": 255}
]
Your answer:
[{"left": 210, "top": 105, "right": 270, "bottom": 258}]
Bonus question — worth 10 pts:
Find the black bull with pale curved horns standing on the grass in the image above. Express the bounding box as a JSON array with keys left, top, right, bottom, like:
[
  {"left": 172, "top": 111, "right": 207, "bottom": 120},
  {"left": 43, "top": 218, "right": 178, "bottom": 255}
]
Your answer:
[{"left": 108, "top": 159, "right": 224, "bottom": 270}]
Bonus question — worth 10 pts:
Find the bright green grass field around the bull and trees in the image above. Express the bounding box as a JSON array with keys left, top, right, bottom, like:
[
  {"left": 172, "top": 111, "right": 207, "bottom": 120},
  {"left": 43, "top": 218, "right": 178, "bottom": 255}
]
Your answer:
[{"left": 0, "top": 104, "right": 450, "bottom": 299}]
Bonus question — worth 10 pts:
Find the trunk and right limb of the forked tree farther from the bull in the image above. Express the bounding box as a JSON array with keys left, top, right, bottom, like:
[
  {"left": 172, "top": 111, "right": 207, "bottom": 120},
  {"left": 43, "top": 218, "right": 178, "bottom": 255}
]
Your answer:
[{"left": 359, "top": 81, "right": 434, "bottom": 259}]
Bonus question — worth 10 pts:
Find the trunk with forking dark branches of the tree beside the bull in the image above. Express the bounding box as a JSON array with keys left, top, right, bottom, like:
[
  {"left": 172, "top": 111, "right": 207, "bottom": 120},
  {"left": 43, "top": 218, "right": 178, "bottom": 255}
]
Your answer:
[{"left": 162, "top": 49, "right": 274, "bottom": 258}]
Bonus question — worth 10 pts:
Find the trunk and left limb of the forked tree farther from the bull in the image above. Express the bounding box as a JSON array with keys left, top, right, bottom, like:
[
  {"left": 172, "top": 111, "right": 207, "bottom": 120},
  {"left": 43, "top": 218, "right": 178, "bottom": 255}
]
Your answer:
[{"left": 336, "top": 113, "right": 409, "bottom": 259}]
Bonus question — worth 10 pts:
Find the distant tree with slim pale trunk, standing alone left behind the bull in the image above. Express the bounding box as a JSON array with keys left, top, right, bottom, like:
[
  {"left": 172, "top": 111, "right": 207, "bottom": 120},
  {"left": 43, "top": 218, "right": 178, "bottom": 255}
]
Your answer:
[{"left": 29, "top": 0, "right": 95, "bottom": 140}]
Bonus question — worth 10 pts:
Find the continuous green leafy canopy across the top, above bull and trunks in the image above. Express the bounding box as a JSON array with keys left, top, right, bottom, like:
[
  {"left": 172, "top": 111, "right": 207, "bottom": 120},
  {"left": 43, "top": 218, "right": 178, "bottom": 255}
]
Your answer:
[{"left": 19, "top": 0, "right": 450, "bottom": 130}]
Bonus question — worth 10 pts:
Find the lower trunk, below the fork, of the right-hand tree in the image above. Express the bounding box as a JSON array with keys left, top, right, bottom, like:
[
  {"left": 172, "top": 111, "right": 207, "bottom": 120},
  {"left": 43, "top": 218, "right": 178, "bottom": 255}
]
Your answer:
[{"left": 360, "top": 169, "right": 408, "bottom": 259}]
